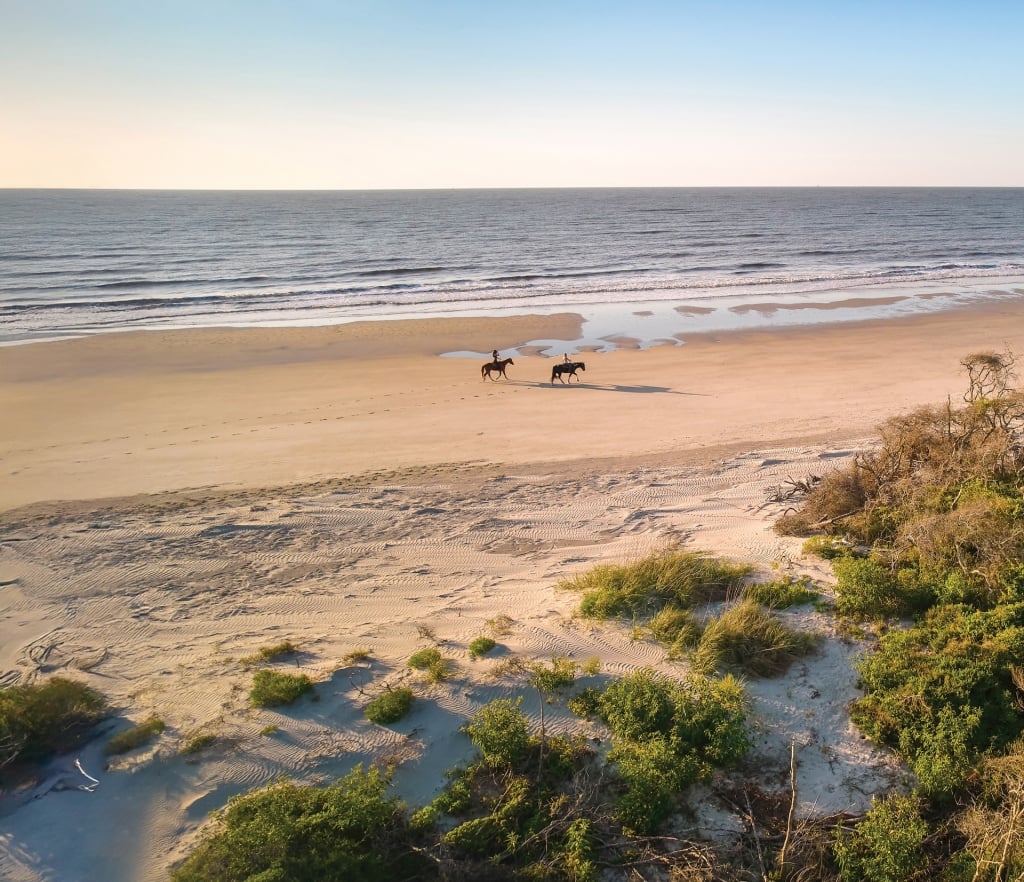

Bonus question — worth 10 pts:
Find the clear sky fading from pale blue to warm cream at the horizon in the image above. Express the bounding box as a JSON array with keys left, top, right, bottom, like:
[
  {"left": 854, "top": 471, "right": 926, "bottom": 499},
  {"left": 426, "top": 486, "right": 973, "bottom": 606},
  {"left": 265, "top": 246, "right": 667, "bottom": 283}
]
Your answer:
[{"left": 0, "top": 0, "right": 1024, "bottom": 190}]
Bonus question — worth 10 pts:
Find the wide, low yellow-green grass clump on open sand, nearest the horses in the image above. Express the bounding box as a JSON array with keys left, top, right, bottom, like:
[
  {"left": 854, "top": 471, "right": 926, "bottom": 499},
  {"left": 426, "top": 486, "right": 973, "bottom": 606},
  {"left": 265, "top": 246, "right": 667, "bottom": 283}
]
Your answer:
[{"left": 557, "top": 550, "right": 751, "bottom": 619}]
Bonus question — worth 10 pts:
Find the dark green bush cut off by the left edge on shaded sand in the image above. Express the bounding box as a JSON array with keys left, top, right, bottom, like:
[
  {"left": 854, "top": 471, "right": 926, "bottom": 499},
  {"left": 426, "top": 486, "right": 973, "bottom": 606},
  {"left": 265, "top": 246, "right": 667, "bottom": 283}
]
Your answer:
[{"left": 0, "top": 677, "right": 108, "bottom": 768}]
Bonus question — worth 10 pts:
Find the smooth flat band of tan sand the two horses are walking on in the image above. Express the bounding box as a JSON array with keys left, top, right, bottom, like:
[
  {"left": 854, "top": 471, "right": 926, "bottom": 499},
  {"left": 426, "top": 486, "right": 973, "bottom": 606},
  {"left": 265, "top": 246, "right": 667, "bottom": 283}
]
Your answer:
[{"left": 0, "top": 299, "right": 1024, "bottom": 511}]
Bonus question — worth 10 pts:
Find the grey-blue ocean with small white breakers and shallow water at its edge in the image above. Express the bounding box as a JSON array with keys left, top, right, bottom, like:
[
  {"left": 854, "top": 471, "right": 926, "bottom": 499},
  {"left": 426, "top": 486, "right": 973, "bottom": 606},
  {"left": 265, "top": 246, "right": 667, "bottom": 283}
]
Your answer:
[{"left": 0, "top": 187, "right": 1024, "bottom": 348}]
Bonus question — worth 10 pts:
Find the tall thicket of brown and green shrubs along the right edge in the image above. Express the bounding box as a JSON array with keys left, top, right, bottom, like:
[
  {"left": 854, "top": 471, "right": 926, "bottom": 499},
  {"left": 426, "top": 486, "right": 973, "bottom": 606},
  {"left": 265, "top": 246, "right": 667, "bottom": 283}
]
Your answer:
[{"left": 777, "top": 352, "right": 1024, "bottom": 811}]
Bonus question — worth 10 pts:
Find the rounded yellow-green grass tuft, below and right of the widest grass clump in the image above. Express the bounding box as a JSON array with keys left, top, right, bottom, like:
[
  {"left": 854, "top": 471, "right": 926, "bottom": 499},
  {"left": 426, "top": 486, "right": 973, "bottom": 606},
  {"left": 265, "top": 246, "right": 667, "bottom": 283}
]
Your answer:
[{"left": 691, "top": 600, "right": 815, "bottom": 677}]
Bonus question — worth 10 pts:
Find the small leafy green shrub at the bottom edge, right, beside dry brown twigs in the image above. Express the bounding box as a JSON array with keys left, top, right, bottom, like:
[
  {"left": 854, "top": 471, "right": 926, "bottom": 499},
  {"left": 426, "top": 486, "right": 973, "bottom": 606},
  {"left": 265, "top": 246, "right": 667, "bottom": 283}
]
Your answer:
[{"left": 833, "top": 794, "right": 928, "bottom": 882}]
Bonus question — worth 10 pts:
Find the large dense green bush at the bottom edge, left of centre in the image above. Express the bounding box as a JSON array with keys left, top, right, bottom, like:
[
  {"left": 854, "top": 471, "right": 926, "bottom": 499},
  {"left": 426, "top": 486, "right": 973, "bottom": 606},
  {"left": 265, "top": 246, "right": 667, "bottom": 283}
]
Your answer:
[{"left": 171, "top": 766, "right": 431, "bottom": 882}]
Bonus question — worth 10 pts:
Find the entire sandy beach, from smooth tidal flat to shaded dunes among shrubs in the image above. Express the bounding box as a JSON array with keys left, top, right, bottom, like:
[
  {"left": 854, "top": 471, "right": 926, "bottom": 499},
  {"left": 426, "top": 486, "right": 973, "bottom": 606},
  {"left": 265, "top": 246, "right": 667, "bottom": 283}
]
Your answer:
[{"left": 0, "top": 298, "right": 1024, "bottom": 882}]
